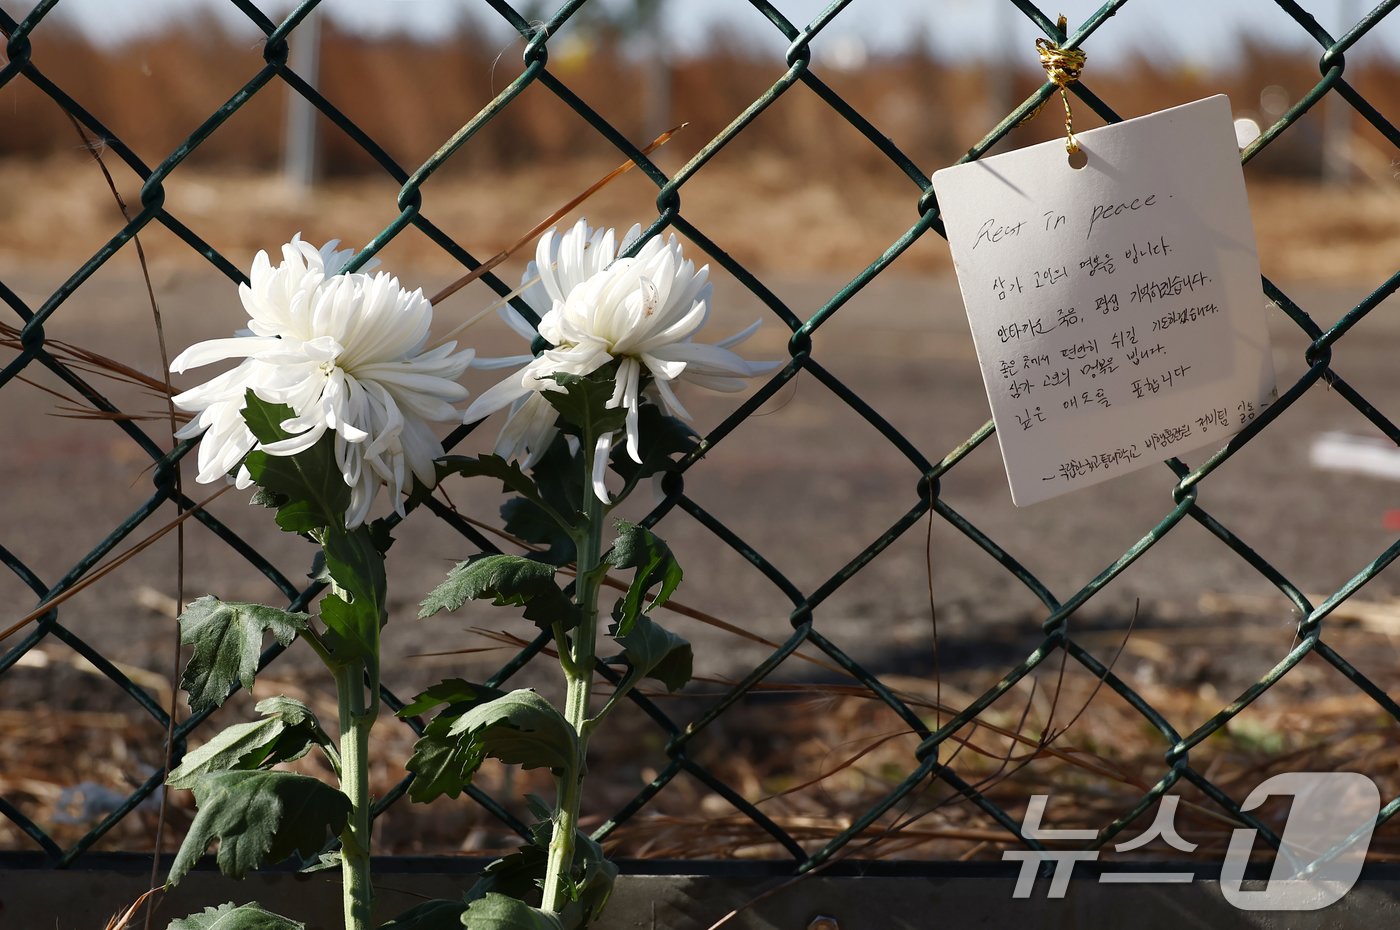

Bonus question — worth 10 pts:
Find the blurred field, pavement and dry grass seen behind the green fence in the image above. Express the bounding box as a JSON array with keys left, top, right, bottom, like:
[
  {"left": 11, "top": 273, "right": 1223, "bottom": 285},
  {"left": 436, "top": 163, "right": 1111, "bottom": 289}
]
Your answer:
[{"left": 0, "top": 1, "right": 1400, "bottom": 861}]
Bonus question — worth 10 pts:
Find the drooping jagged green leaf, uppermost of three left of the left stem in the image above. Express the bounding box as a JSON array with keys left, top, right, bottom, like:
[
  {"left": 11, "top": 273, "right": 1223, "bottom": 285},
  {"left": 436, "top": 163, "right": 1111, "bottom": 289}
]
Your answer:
[{"left": 179, "top": 595, "right": 311, "bottom": 713}]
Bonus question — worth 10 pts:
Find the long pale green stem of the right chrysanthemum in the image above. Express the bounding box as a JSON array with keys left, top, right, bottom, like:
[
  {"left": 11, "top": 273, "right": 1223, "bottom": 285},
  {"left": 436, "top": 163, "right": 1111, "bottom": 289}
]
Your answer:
[{"left": 542, "top": 450, "right": 608, "bottom": 913}]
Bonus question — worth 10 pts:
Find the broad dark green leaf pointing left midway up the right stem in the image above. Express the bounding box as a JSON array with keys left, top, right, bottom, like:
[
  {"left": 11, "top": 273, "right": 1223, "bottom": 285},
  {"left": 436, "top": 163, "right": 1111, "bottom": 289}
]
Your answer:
[{"left": 419, "top": 555, "right": 578, "bottom": 629}]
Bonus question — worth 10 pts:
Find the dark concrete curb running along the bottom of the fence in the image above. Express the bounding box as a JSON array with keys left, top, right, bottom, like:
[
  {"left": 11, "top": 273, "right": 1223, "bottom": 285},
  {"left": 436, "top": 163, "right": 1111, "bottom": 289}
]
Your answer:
[{"left": 0, "top": 854, "right": 1400, "bottom": 930}]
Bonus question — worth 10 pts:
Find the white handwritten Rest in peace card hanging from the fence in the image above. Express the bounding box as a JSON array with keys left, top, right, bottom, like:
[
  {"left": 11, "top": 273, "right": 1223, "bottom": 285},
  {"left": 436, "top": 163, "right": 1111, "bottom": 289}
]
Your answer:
[{"left": 934, "top": 97, "right": 1275, "bottom": 506}]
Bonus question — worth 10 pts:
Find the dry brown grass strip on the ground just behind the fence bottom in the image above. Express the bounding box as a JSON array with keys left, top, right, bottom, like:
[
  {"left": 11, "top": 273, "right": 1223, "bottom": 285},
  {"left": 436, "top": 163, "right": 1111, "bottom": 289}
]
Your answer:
[{"left": 8, "top": 604, "right": 1400, "bottom": 863}]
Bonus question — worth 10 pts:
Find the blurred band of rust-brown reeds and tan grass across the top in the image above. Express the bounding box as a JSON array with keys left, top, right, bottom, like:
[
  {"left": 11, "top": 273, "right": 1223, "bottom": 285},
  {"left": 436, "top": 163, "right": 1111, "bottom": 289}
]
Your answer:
[{"left": 0, "top": 4, "right": 1400, "bottom": 280}]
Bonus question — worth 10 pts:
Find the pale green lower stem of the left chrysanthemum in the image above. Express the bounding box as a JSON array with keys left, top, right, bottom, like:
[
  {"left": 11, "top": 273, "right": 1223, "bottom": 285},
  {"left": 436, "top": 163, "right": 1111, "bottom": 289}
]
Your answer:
[{"left": 335, "top": 664, "right": 374, "bottom": 930}]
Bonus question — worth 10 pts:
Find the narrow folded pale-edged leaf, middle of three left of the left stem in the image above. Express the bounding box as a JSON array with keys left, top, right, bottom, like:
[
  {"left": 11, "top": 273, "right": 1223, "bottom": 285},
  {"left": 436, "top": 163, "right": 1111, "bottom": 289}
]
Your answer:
[{"left": 165, "top": 696, "right": 330, "bottom": 789}]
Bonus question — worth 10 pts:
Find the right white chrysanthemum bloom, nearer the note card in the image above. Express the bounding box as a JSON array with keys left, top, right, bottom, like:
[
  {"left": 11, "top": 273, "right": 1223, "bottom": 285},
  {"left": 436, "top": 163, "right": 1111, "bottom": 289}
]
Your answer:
[{"left": 462, "top": 220, "right": 781, "bottom": 501}]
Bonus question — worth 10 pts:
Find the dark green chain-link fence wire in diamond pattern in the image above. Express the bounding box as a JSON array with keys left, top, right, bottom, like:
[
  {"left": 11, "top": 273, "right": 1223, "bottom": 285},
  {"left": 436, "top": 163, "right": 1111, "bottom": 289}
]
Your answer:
[{"left": 0, "top": 0, "right": 1400, "bottom": 870}]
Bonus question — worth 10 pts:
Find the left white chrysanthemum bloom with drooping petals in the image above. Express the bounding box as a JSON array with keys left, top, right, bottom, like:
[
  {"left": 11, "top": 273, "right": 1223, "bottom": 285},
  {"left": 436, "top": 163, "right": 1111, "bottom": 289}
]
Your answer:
[{"left": 171, "top": 235, "right": 475, "bottom": 528}]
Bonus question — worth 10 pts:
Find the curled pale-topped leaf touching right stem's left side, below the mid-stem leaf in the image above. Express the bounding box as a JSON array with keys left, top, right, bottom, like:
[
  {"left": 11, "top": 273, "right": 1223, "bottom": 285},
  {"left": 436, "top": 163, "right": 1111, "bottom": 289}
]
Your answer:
[{"left": 448, "top": 689, "right": 578, "bottom": 769}]
